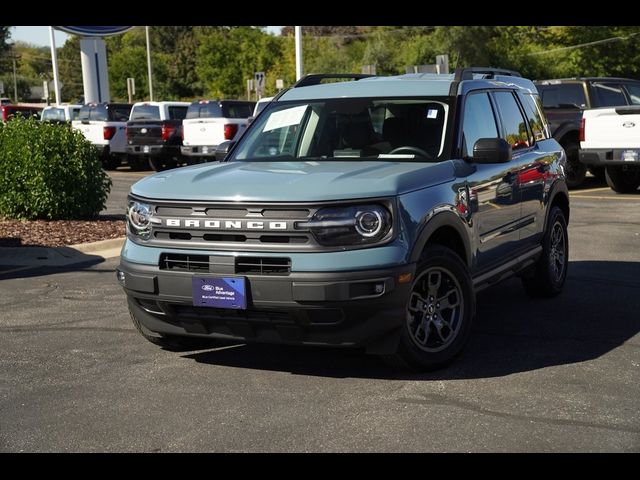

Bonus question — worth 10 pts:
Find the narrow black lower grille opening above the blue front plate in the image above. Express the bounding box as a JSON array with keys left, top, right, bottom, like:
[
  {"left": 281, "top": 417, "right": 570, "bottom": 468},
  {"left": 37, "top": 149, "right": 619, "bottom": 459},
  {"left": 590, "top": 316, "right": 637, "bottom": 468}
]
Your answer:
[{"left": 160, "top": 253, "right": 291, "bottom": 275}]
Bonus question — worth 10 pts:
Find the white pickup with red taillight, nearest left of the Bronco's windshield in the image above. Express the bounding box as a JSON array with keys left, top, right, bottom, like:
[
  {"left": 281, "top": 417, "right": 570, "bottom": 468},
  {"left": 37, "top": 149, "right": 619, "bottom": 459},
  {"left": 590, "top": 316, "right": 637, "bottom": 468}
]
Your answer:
[{"left": 181, "top": 100, "right": 255, "bottom": 163}]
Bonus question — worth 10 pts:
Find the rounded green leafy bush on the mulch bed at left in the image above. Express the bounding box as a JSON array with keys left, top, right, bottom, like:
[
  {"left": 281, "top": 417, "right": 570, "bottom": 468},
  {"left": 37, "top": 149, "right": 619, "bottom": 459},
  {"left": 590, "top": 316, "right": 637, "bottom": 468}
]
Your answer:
[{"left": 0, "top": 117, "right": 111, "bottom": 220}]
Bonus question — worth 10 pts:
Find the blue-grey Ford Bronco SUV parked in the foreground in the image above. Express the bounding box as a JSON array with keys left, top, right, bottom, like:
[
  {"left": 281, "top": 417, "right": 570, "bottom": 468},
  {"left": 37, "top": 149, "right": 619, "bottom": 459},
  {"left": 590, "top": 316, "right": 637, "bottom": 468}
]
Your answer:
[{"left": 116, "top": 68, "right": 569, "bottom": 370}]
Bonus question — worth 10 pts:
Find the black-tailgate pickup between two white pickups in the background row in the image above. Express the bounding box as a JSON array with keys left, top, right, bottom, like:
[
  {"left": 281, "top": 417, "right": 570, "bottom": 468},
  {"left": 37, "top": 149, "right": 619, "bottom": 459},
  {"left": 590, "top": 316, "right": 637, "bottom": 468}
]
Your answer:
[{"left": 127, "top": 102, "right": 189, "bottom": 171}]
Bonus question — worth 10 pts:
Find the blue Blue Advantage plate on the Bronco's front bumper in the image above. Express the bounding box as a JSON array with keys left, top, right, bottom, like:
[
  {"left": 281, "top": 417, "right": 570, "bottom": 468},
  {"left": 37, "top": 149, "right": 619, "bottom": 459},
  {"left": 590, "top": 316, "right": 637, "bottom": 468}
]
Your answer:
[{"left": 191, "top": 277, "right": 247, "bottom": 310}]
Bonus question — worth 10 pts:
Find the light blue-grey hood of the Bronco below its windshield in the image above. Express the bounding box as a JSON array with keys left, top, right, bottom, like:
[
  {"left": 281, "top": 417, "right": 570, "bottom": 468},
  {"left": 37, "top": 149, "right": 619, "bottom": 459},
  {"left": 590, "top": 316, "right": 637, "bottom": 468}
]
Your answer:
[{"left": 131, "top": 161, "right": 454, "bottom": 202}]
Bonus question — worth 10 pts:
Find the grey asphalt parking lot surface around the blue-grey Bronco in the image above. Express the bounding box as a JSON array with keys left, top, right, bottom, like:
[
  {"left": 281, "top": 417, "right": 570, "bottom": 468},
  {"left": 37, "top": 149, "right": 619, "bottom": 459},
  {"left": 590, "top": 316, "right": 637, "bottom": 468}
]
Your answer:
[{"left": 0, "top": 169, "right": 640, "bottom": 452}]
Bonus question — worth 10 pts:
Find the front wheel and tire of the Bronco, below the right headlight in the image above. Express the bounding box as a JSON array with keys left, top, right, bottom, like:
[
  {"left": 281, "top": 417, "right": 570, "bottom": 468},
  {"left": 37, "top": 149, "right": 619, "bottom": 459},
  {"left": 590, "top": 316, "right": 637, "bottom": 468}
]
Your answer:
[{"left": 386, "top": 245, "right": 475, "bottom": 371}]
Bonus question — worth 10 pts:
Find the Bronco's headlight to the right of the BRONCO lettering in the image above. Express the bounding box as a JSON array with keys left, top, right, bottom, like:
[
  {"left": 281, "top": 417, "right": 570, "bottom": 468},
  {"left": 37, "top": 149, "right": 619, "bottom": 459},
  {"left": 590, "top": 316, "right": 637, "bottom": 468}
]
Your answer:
[{"left": 297, "top": 205, "right": 392, "bottom": 246}]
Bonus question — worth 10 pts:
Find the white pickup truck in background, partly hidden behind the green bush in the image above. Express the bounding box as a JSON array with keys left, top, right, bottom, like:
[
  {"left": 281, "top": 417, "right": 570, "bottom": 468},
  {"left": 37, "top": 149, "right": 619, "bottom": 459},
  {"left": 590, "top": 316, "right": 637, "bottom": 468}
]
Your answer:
[{"left": 71, "top": 103, "right": 131, "bottom": 170}]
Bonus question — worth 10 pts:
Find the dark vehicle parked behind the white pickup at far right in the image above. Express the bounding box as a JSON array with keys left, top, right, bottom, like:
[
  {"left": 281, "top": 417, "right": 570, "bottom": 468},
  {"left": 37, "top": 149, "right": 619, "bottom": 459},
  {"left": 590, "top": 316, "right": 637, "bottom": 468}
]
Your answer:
[{"left": 534, "top": 77, "right": 640, "bottom": 188}]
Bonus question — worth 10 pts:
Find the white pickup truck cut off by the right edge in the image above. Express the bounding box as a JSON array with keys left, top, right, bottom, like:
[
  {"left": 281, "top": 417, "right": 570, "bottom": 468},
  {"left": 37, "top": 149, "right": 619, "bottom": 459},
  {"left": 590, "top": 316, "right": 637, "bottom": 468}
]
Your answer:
[{"left": 580, "top": 105, "right": 640, "bottom": 193}]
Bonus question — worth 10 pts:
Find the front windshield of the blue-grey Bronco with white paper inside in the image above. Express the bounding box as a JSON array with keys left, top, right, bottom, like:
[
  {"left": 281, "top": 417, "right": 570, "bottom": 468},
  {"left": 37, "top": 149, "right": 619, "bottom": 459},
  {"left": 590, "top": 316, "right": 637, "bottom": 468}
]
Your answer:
[{"left": 230, "top": 97, "right": 450, "bottom": 161}]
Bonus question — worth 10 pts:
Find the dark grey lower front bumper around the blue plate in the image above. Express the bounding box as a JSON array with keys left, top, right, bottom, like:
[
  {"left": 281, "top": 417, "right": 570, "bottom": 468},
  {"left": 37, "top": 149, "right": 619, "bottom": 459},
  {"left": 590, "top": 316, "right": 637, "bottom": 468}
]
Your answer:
[{"left": 117, "top": 260, "right": 415, "bottom": 353}]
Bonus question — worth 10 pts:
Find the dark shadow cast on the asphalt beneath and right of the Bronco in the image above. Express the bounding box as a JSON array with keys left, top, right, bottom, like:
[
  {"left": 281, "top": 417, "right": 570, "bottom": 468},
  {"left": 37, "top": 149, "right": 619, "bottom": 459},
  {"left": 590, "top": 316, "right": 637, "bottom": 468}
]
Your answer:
[{"left": 185, "top": 261, "right": 640, "bottom": 380}]
